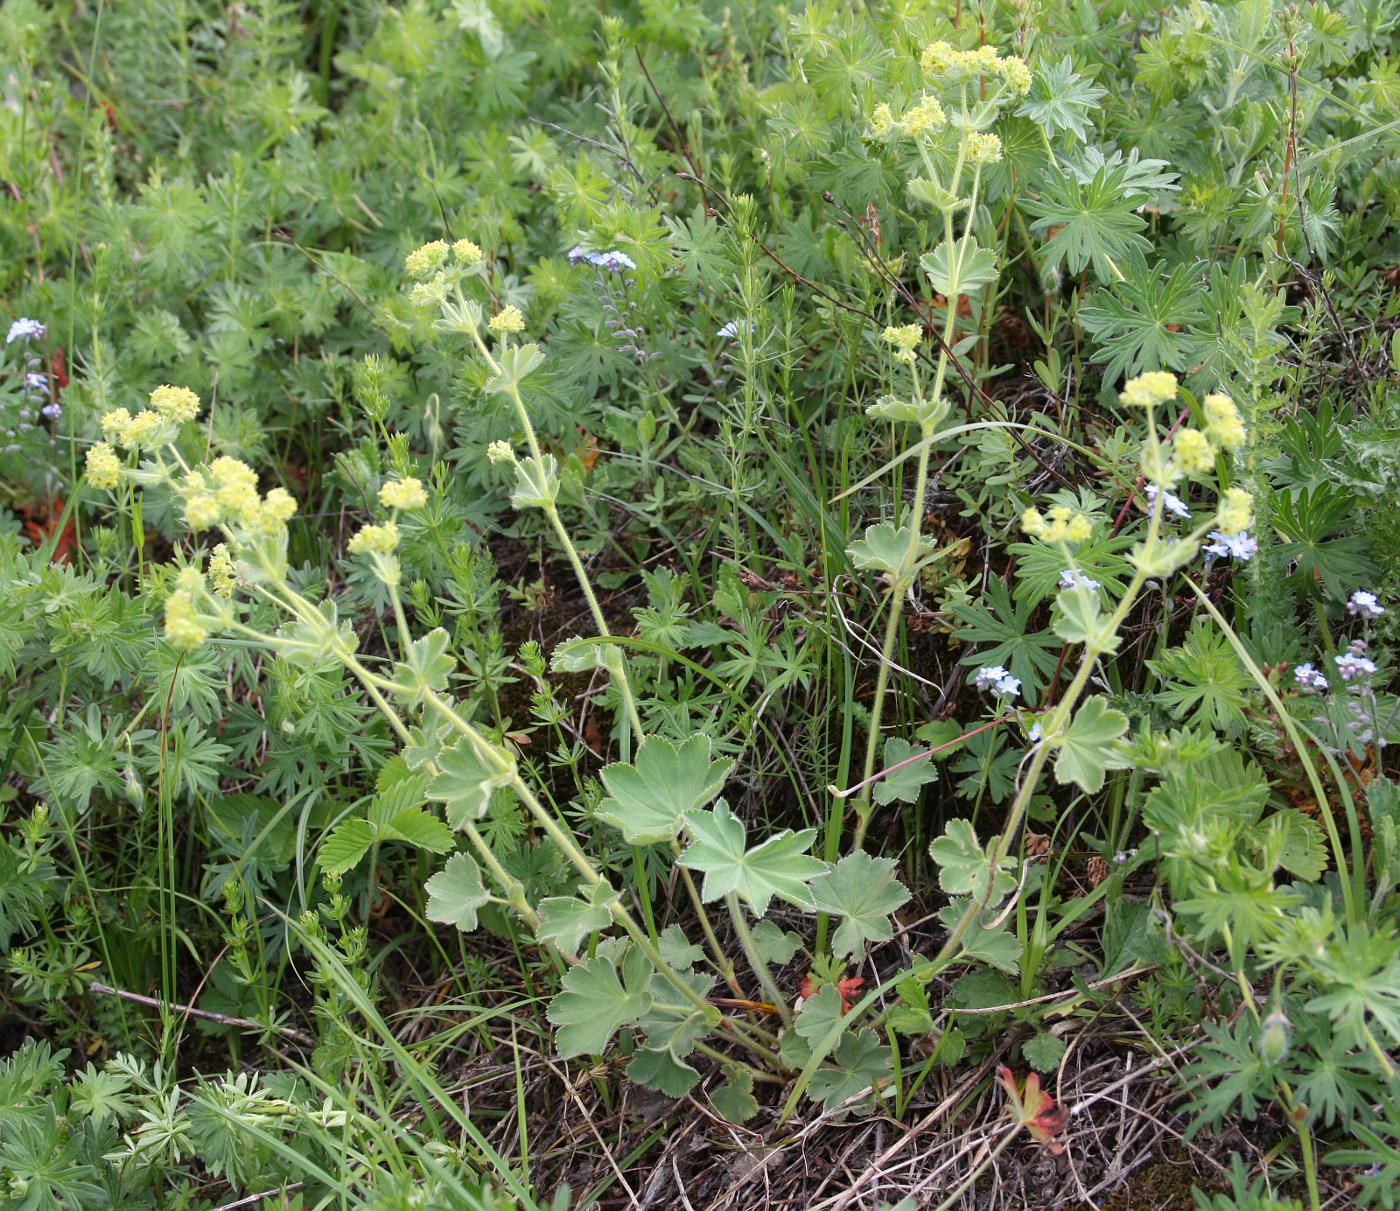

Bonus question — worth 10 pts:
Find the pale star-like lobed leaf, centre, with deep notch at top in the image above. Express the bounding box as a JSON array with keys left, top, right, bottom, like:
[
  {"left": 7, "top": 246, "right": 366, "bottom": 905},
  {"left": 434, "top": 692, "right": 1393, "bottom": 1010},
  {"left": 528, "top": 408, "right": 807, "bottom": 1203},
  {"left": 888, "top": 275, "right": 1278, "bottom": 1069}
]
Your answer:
[{"left": 678, "top": 799, "right": 826, "bottom": 917}]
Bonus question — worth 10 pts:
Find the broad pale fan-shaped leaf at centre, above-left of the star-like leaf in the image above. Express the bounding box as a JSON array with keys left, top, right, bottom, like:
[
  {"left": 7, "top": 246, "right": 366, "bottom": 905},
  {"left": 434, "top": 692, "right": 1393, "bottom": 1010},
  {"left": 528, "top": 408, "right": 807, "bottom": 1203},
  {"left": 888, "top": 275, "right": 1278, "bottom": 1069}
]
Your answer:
[{"left": 596, "top": 735, "right": 734, "bottom": 846}]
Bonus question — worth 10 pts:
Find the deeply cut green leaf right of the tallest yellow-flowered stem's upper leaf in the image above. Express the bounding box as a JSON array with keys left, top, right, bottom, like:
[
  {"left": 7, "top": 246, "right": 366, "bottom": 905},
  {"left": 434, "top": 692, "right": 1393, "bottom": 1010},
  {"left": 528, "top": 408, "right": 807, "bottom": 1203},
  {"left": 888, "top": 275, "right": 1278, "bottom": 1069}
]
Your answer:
[{"left": 1021, "top": 164, "right": 1152, "bottom": 281}]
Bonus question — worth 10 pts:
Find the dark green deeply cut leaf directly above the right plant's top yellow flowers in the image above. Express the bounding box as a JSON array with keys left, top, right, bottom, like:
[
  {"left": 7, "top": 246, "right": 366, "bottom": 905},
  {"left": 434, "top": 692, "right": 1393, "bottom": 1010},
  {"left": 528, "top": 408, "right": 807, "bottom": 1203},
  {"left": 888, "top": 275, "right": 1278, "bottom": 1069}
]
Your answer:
[{"left": 1079, "top": 256, "right": 1204, "bottom": 382}]
